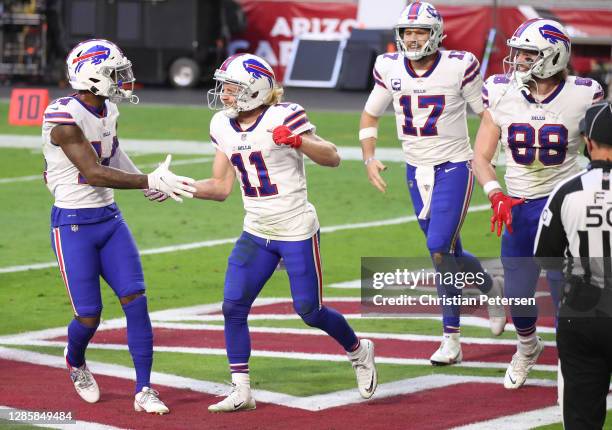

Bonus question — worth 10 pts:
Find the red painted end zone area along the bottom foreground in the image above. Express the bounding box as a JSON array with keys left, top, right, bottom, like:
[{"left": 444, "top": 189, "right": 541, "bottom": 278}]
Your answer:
[{"left": 0, "top": 358, "right": 556, "bottom": 430}]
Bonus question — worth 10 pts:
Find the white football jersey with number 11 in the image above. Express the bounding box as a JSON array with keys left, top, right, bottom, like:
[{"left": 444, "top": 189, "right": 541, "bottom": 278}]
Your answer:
[{"left": 210, "top": 103, "right": 319, "bottom": 241}]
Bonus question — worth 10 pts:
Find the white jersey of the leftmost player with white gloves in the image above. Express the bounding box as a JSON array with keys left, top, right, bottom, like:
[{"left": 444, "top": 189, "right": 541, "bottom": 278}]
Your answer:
[{"left": 42, "top": 95, "right": 119, "bottom": 209}]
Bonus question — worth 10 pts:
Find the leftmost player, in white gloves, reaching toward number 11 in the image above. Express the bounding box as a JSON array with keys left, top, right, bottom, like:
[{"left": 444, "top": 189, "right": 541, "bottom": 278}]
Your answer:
[{"left": 42, "top": 39, "right": 195, "bottom": 414}]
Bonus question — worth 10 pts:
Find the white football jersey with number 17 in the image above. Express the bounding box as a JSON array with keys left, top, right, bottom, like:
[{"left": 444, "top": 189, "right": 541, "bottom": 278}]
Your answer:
[{"left": 366, "top": 51, "right": 484, "bottom": 166}]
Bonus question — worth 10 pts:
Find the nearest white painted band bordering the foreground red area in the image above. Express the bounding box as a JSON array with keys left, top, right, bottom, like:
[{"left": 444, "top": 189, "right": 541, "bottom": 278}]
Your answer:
[{"left": 0, "top": 347, "right": 555, "bottom": 411}]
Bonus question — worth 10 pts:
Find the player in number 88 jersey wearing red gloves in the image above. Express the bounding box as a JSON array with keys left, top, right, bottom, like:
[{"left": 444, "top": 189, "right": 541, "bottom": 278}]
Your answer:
[{"left": 474, "top": 19, "right": 603, "bottom": 389}]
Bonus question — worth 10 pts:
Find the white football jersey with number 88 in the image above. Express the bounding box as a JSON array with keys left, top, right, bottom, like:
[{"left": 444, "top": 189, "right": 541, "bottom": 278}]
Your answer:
[{"left": 482, "top": 75, "right": 603, "bottom": 199}]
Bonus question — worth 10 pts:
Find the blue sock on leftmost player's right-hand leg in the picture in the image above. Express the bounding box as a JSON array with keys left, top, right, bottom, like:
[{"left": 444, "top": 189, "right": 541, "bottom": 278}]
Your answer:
[{"left": 122, "top": 295, "right": 153, "bottom": 393}]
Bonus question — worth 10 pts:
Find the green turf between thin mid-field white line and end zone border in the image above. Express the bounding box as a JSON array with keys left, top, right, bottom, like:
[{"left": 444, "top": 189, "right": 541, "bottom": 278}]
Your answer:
[{"left": 0, "top": 212, "right": 502, "bottom": 334}]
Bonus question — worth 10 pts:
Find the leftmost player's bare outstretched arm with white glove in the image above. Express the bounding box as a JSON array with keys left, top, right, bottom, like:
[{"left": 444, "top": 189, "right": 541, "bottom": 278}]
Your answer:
[{"left": 51, "top": 125, "right": 193, "bottom": 201}]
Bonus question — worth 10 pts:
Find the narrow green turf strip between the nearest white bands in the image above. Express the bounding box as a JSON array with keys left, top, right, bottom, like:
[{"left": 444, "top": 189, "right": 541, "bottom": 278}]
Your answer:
[{"left": 7, "top": 346, "right": 556, "bottom": 396}]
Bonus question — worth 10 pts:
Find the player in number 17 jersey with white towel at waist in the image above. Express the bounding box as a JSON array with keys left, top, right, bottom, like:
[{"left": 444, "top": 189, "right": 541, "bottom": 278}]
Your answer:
[{"left": 359, "top": 2, "right": 506, "bottom": 365}]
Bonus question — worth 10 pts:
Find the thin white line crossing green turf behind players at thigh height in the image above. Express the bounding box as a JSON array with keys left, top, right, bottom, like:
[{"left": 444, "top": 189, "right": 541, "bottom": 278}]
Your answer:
[{"left": 0, "top": 205, "right": 490, "bottom": 273}]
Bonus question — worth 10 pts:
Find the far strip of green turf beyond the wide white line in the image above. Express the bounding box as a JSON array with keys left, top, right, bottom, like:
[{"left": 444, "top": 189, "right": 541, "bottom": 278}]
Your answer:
[{"left": 0, "top": 100, "right": 479, "bottom": 148}]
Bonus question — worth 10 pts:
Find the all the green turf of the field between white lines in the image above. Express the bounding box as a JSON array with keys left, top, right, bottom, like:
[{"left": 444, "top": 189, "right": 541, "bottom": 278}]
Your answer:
[{"left": 0, "top": 103, "right": 554, "bottom": 428}]
